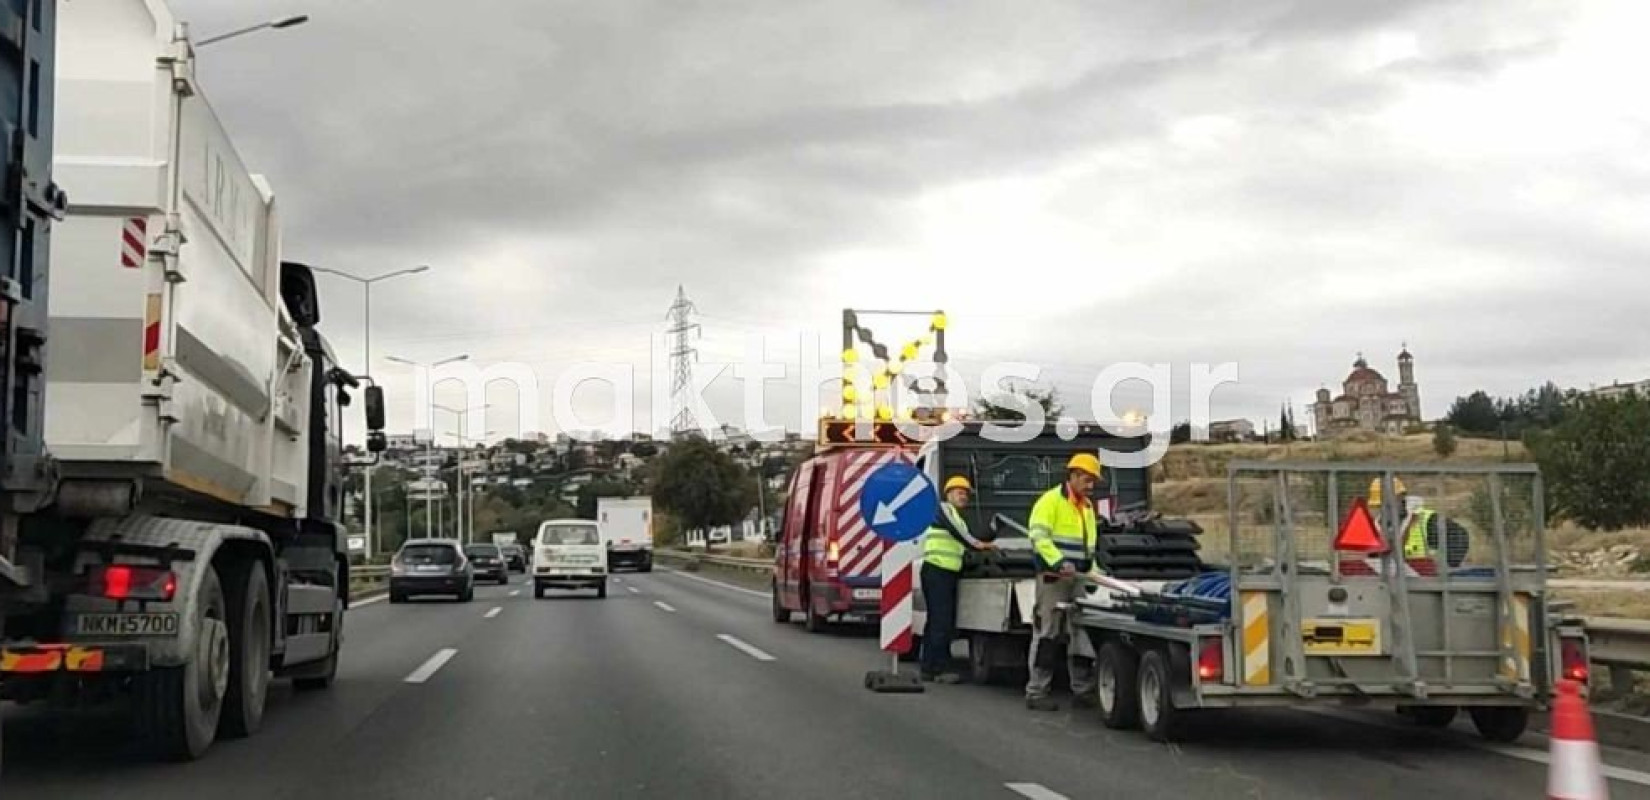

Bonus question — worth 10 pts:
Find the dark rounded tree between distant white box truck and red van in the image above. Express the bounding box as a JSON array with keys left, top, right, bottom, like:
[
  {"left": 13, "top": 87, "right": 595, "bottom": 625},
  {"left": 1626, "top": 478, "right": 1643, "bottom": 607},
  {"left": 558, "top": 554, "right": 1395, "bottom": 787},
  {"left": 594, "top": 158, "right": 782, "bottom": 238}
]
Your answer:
[{"left": 648, "top": 437, "right": 756, "bottom": 541}]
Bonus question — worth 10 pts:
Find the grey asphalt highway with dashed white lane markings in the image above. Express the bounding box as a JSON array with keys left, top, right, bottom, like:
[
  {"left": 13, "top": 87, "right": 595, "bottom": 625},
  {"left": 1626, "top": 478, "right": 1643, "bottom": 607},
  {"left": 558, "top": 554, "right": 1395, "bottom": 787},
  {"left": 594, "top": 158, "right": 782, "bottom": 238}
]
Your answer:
[{"left": 0, "top": 572, "right": 1650, "bottom": 800}]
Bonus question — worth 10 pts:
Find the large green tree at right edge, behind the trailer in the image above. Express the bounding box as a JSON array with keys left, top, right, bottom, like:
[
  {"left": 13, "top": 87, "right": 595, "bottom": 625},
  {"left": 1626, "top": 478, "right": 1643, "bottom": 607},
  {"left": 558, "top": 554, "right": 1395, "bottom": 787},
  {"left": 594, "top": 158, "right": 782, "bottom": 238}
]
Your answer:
[{"left": 1525, "top": 394, "right": 1650, "bottom": 531}]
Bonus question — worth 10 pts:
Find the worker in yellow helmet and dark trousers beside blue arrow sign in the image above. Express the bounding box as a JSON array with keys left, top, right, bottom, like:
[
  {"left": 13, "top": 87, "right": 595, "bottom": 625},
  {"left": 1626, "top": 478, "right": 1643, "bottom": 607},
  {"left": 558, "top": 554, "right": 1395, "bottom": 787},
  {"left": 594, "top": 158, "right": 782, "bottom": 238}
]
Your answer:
[{"left": 921, "top": 475, "right": 995, "bottom": 683}]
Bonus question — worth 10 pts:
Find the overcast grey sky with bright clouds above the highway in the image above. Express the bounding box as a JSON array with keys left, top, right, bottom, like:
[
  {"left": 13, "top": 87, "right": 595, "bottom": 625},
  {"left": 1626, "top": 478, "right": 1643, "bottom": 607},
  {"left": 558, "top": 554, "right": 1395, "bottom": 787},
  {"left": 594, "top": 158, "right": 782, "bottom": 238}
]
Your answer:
[{"left": 173, "top": 0, "right": 1650, "bottom": 432}]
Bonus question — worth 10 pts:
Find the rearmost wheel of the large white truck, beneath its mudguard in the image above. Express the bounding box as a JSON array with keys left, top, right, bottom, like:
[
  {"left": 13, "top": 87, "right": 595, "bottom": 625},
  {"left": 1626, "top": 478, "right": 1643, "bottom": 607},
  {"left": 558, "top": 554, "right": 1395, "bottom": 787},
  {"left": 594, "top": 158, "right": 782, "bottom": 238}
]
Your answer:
[{"left": 132, "top": 566, "right": 229, "bottom": 760}]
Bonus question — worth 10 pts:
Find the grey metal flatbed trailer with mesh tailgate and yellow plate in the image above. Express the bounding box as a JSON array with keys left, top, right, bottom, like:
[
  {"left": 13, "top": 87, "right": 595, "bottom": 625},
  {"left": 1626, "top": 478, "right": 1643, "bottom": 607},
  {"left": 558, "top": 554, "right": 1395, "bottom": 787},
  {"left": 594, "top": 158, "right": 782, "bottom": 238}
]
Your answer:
[{"left": 1079, "top": 462, "right": 1587, "bottom": 742}]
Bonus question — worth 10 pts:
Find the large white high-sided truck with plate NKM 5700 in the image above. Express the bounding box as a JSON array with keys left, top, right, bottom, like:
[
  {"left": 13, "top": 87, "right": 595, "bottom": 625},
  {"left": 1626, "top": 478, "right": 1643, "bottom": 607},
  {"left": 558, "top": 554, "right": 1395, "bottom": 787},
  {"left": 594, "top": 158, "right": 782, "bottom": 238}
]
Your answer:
[{"left": 0, "top": 0, "right": 383, "bottom": 760}]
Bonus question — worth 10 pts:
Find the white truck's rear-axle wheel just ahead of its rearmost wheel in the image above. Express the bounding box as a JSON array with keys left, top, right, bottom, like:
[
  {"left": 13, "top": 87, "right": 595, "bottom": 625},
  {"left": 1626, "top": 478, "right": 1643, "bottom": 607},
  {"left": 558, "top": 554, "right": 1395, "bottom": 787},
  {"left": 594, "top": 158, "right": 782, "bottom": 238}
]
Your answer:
[{"left": 218, "top": 561, "right": 271, "bottom": 739}]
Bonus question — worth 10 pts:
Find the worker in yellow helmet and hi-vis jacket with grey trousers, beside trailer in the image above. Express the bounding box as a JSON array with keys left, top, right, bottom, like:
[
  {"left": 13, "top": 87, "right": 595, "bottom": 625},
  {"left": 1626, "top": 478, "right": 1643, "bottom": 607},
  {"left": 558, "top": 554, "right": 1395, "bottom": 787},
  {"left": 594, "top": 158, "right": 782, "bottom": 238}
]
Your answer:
[{"left": 1026, "top": 452, "right": 1101, "bottom": 711}]
